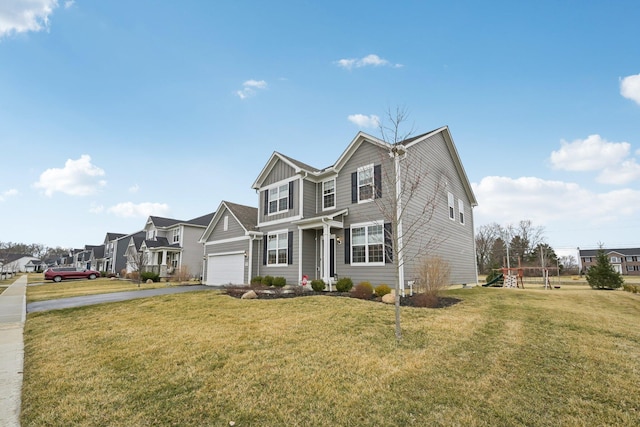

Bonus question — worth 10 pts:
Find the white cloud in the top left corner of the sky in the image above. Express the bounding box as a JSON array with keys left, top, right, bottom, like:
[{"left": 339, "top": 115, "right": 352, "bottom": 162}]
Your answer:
[{"left": 0, "top": 0, "right": 58, "bottom": 38}]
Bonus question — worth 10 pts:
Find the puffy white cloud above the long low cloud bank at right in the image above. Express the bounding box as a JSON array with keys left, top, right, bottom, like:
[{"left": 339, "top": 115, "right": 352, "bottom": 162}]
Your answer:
[{"left": 551, "top": 135, "right": 631, "bottom": 171}]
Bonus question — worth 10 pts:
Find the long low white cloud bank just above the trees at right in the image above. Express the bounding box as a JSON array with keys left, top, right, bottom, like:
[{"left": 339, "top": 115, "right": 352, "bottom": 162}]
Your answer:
[{"left": 472, "top": 176, "right": 640, "bottom": 226}]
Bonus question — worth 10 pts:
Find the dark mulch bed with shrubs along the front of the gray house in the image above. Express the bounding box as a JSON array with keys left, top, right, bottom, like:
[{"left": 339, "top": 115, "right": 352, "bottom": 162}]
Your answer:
[{"left": 224, "top": 287, "right": 462, "bottom": 308}]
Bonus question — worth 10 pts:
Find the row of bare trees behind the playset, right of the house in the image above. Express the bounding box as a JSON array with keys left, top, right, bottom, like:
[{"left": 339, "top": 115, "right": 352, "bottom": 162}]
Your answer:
[{"left": 476, "top": 220, "right": 578, "bottom": 274}]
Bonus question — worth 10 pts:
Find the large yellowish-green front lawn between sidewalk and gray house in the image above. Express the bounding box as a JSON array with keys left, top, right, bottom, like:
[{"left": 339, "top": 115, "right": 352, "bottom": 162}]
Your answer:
[{"left": 21, "top": 287, "right": 640, "bottom": 426}]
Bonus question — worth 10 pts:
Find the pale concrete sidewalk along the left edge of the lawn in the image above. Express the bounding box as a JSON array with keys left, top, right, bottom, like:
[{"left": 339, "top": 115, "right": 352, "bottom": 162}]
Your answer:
[{"left": 0, "top": 275, "right": 27, "bottom": 427}]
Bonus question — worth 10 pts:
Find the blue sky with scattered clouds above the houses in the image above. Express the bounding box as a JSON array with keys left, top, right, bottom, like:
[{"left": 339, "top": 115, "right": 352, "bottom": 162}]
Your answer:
[{"left": 0, "top": 0, "right": 640, "bottom": 253}]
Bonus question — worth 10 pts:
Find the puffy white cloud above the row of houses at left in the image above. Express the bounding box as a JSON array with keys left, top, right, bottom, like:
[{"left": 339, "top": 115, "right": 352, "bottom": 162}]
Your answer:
[{"left": 33, "top": 154, "right": 107, "bottom": 197}]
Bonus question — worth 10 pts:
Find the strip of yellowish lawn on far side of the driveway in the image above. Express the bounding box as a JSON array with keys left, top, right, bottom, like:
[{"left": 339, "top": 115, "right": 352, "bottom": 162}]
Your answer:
[{"left": 27, "top": 277, "right": 176, "bottom": 302}]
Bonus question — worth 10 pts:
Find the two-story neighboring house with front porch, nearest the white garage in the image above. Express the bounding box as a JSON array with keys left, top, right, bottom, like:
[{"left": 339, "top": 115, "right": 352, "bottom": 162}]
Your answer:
[{"left": 140, "top": 212, "right": 215, "bottom": 278}]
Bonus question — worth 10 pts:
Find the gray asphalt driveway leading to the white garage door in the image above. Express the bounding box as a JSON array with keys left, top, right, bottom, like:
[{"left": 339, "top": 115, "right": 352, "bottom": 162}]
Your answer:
[{"left": 27, "top": 285, "right": 219, "bottom": 313}]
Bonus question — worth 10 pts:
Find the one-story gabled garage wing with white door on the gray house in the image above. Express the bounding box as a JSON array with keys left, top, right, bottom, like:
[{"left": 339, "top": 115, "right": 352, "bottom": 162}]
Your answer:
[{"left": 200, "top": 201, "right": 262, "bottom": 285}]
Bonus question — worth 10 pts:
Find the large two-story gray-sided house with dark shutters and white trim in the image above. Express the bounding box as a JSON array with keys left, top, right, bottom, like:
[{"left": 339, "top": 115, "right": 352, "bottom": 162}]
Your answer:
[{"left": 202, "top": 126, "right": 477, "bottom": 289}]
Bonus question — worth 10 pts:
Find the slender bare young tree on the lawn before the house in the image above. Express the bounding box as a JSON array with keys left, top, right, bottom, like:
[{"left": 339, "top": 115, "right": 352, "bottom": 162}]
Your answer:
[{"left": 375, "top": 107, "right": 443, "bottom": 341}]
